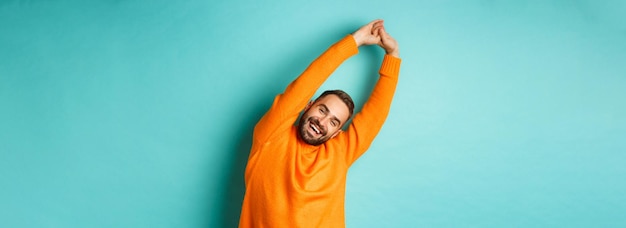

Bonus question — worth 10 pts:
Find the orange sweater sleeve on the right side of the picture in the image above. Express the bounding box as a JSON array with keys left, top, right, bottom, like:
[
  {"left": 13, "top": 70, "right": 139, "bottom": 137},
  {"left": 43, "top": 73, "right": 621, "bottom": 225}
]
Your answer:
[{"left": 340, "top": 55, "right": 401, "bottom": 165}]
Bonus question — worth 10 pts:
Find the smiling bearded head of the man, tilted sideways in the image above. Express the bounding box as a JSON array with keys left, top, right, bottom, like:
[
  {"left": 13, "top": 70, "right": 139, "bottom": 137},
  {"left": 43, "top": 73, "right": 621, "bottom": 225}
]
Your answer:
[{"left": 298, "top": 90, "right": 354, "bottom": 146}]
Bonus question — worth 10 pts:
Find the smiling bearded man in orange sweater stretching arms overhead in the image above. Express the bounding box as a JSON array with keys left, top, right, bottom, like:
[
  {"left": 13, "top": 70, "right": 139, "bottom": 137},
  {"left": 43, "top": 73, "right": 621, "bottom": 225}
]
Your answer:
[{"left": 239, "top": 20, "right": 401, "bottom": 227}]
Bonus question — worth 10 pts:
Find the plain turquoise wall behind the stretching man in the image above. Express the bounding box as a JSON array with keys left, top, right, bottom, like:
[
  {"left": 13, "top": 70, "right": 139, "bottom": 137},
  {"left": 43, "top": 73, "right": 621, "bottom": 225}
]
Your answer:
[{"left": 0, "top": 0, "right": 626, "bottom": 227}]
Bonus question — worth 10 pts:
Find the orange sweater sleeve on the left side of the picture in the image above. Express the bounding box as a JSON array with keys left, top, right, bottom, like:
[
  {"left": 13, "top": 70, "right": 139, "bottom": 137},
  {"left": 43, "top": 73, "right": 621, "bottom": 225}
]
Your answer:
[{"left": 251, "top": 35, "right": 358, "bottom": 147}]
